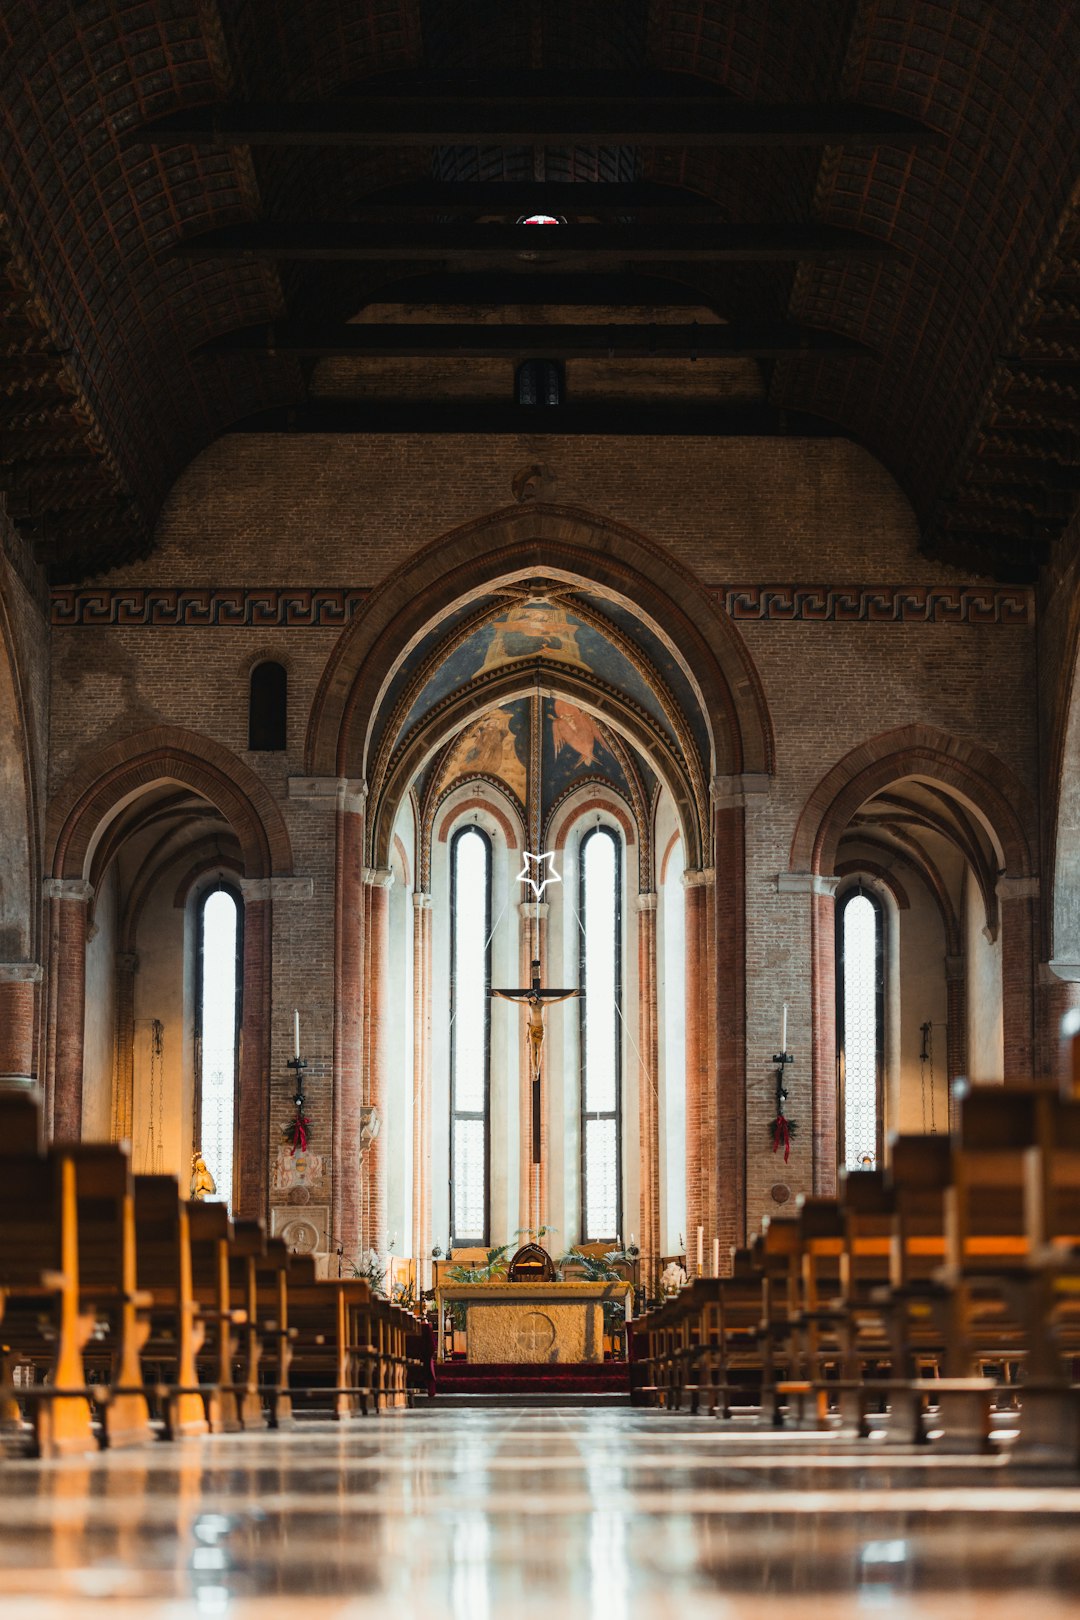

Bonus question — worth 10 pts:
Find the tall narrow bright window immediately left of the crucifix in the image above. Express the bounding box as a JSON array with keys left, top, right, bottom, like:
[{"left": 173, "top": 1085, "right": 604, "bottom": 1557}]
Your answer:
[{"left": 450, "top": 826, "right": 491, "bottom": 1244}]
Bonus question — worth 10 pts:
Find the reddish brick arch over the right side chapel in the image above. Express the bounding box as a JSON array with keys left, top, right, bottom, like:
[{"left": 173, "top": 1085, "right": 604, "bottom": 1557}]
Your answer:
[{"left": 789, "top": 726, "right": 1038, "bottom": 878}]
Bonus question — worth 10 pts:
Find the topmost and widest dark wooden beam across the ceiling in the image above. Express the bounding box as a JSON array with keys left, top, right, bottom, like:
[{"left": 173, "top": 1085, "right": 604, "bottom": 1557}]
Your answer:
[{"left": 123, "top": 81, "right": 942, "bottom": 147}]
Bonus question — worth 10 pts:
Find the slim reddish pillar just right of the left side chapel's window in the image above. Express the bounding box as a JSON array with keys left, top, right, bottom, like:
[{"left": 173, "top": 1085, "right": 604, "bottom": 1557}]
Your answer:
[{"left": 233, "top": 878, "right": 274, "bottom": 1220}]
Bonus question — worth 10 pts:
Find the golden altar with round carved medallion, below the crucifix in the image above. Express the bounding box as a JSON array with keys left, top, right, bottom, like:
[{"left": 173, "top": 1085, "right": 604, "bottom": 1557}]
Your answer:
[{"left": 437, "top": 1281, "right": 631, "bottom": 1364}]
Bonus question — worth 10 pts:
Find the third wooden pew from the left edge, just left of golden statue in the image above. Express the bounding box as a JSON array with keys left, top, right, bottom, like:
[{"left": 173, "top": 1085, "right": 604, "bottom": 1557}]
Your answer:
[{"left": 134, "top": 1176, "right": 209, "bottom": 1439}]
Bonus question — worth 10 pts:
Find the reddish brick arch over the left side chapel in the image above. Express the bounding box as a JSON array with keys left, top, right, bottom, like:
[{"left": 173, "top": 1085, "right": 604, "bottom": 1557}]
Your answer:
[{"left": 45, "top": 726, "right": 293, "bottom": 878}]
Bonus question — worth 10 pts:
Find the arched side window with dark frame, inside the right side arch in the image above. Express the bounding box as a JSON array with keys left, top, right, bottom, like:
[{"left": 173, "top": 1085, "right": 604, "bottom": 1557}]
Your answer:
[{"left": 836, "top": 888, "right": 884, "bottom": 1170}]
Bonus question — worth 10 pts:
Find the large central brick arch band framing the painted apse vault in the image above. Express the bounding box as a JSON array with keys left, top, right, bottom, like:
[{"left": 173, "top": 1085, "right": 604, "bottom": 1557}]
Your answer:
[{"left": 304, "top": 505, "right": 774, "bottom": 776}]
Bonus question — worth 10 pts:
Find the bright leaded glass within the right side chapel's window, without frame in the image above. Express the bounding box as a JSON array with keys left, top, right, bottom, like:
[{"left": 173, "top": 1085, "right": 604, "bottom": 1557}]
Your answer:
[{"left": 844, "top": 894, "right": 879, "bottom": 1170}]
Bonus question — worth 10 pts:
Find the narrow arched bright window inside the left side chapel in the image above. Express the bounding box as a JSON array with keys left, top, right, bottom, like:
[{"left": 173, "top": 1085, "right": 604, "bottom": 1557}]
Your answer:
[{"left": 194, "top": 889, "right": 241, "bottom": 1209}]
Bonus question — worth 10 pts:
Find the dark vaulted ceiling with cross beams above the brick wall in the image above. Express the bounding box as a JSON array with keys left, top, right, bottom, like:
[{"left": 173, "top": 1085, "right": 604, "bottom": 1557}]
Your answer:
[{"left": 0, "top": 0, "right": 1080, "bottom": 580}]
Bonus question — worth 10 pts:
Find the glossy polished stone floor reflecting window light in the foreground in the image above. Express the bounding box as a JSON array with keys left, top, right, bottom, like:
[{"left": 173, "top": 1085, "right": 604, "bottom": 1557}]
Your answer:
[{"left": 0, "top": 1406, "right": 1080, "bottom": 1620}]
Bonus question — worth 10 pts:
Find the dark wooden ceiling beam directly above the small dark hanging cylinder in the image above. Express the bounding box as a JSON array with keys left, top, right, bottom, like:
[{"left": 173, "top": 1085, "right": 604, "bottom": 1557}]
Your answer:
[{"left": 202, "top": 321, "right": 873, "bottom": 360}]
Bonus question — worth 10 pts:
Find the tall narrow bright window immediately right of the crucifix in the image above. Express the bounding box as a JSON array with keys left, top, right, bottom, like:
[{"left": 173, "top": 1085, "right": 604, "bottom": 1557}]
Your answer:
[{"left": 580, "top": 826, "right": 622, "bottom": 1243}]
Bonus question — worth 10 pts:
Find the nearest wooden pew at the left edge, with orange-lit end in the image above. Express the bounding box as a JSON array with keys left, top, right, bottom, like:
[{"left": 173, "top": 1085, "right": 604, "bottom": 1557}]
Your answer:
[{"left": 0, "top": 1094, "right": 97, "bottom": 1456}]
